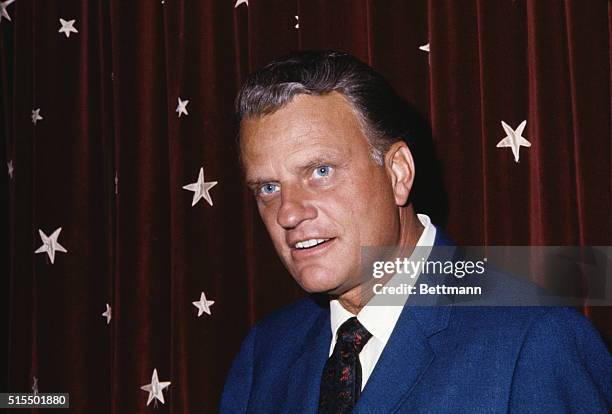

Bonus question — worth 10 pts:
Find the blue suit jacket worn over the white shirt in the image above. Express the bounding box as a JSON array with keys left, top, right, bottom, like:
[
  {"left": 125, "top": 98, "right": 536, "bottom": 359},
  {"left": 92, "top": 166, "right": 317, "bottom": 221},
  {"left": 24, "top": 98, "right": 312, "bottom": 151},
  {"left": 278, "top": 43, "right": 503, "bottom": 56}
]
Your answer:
[{"left": 220, "top": 231, "right": 612, "bottom": 414}]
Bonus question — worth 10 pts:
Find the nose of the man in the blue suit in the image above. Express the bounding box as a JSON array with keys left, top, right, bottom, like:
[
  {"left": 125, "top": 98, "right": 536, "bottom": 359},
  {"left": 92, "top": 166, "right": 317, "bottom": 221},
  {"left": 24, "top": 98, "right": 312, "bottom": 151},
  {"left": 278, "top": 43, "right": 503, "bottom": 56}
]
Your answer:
[{"left": 276, "top": 184, "right": 317, "bottom": 230}]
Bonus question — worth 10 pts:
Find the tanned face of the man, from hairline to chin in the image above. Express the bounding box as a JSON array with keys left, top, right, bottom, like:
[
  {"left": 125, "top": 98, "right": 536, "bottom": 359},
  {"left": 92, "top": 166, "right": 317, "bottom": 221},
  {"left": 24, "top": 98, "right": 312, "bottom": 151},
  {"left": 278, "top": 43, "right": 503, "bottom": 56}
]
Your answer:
[{"left": 240, "top": 92, "right": 399, "bottom": 295}]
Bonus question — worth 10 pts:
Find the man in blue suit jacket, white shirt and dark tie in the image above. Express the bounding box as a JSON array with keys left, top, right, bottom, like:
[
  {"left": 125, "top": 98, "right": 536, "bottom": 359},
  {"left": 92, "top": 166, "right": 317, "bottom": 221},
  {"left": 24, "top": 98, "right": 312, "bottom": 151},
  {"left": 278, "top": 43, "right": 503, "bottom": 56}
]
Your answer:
[{"left": 221, "top": 52, "right": 612, "bottom": 413}]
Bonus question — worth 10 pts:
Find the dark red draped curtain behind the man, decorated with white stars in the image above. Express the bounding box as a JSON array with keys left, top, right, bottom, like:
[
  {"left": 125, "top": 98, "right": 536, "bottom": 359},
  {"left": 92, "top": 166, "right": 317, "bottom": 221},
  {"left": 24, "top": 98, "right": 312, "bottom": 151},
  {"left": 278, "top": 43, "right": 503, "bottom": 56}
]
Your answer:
[{"left": 0, "top": 0, "right": 612, "bottom": 413}]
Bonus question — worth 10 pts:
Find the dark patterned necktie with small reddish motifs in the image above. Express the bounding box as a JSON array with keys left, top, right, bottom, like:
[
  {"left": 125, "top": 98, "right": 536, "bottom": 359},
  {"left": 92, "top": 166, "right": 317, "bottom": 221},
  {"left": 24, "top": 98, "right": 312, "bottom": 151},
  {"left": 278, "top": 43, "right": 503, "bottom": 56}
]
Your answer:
[{"left": 319, "top": 317, "right": 372, "bottom": 414}]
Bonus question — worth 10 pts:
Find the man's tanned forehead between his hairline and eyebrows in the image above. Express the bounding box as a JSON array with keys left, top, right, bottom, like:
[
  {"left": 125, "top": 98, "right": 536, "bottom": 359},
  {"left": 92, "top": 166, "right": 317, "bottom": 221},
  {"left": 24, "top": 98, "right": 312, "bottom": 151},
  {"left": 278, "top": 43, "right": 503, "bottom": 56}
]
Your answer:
[{"left": 240, "top": 92, "right": 369, "bottom": 171}]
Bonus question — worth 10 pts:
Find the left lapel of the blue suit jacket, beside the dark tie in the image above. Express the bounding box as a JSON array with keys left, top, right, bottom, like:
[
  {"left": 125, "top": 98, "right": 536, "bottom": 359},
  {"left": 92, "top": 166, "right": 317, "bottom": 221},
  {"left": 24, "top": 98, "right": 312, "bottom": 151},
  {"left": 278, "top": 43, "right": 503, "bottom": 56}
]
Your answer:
[{"left": 285, "top": 309, "right": 331, "bottom": 413}]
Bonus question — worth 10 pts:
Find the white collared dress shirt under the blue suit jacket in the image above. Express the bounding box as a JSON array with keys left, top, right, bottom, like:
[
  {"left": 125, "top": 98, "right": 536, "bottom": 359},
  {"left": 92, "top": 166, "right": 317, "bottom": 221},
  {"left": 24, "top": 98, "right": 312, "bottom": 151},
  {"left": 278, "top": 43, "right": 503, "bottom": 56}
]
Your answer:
[{"left": 329, "top": 214, "right": 436, "bottom": 390}]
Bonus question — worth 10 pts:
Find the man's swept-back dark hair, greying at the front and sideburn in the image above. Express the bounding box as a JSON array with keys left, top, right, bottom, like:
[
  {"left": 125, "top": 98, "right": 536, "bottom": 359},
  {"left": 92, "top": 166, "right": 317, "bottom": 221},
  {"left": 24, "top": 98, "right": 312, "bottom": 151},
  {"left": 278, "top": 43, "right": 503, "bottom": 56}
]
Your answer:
[{"left": 235, "top": 51, "right": 410, "bottom": 165}]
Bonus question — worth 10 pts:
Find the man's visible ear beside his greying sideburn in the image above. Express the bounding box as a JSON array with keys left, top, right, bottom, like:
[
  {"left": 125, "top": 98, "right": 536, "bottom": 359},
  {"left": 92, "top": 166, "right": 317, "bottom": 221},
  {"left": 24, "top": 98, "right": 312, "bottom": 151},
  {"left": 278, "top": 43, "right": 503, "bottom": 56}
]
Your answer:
[{"left": 385, "top": 141, "right": 414, "bottom": 206}]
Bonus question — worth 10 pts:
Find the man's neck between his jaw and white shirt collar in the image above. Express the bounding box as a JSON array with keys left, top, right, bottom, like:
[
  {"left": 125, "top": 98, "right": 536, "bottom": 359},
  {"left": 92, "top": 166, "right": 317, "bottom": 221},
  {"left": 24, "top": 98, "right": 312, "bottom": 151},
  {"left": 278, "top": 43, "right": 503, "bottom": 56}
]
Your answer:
[{"left": 337, "top": 206, "right": 425, "bottom": 315}]
